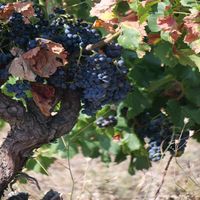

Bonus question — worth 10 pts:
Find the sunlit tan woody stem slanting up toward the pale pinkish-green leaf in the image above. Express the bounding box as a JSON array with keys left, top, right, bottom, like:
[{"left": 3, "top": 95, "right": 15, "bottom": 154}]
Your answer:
[{"left": 85, "top": 30, "right": 121, "bottom": 51}]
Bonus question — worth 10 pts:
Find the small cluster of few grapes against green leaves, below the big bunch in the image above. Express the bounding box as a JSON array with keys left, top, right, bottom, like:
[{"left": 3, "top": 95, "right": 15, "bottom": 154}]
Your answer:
[{"left": 96, "top": 115, "right": 117, "bottom": 128}]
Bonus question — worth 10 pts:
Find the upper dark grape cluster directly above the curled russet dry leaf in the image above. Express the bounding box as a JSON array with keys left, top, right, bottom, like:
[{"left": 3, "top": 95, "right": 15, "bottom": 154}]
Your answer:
[{"left": 38, "top": 9, "right": 101, "bottom": 53}]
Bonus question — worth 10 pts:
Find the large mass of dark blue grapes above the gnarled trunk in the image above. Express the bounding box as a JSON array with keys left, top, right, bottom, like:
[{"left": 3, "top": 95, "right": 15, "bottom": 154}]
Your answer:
[{"left": 0, "top": 2, "right": 130, "bottom": 115}]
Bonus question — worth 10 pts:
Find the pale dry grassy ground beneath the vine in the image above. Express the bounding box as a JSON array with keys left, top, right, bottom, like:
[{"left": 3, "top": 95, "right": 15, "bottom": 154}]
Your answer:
[{"left": 0, "top": 124, "right": 200, "bottom": 200}]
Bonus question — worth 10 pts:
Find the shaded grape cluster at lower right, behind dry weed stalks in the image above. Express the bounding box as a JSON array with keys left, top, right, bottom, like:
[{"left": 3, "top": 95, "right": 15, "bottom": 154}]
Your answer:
[{"left": 135, "top": 113, "right": 189, "bottom": 161}]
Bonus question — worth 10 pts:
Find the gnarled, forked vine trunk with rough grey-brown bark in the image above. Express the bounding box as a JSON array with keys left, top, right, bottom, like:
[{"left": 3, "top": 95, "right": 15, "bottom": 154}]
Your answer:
[{"left": 0, "top": 91, "right": 80, "bottom": 197}]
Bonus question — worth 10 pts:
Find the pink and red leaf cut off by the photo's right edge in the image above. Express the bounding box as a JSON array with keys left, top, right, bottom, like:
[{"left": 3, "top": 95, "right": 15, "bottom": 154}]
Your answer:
[{"left": 184, "top": 9, "right": 200, "bottom": 54}]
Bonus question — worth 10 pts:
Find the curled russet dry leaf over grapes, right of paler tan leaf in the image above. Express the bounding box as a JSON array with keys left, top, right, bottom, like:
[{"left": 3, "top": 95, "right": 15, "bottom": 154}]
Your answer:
[{"left": 22, "top": 38, "right": 67, "bottom": 78}]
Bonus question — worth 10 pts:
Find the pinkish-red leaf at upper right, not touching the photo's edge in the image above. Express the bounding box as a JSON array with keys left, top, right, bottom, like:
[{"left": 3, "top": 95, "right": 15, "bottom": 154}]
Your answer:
[{"left": 157, "top": 15, "right": 181, "bottom": 44}]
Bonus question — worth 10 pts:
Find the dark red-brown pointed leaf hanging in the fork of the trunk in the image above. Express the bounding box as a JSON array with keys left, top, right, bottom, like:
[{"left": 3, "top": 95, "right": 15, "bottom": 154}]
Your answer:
[{"left": 31, "top": 83, "right": 56, "bottom": 117}]
